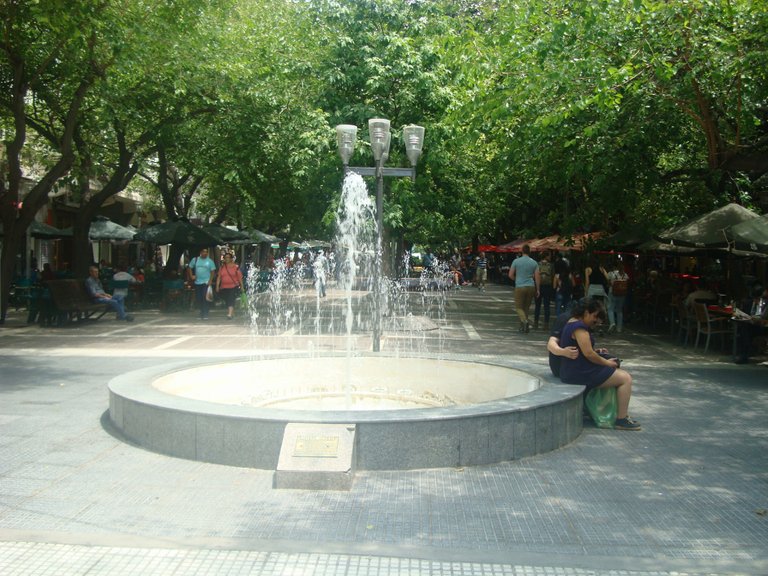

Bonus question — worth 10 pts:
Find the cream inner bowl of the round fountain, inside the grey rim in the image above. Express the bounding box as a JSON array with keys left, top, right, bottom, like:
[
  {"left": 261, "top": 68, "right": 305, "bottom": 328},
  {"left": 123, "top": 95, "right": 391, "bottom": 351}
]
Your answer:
[{"left": 153, "top": 357, "right": 540, "bottom": 412}]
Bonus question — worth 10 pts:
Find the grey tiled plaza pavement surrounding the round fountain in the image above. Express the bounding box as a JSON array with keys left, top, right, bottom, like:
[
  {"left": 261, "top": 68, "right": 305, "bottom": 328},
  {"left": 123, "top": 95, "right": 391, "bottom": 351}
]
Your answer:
[{"left": 0, "top": 285, "right": 768, "bottom": 576}]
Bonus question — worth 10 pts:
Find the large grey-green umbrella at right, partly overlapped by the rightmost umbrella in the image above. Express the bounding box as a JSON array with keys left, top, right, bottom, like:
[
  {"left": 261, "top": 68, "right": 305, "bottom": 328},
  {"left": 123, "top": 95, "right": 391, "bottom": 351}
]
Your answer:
[{"left": 657, "top": 204, "right": 759, "bottom": 248}]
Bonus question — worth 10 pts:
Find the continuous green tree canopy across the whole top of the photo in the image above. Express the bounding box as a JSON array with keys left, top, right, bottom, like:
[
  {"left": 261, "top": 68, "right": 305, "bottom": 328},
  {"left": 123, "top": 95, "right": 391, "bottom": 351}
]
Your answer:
[{"left": 0, "top": 0, "right": 768, "bottom": 316}]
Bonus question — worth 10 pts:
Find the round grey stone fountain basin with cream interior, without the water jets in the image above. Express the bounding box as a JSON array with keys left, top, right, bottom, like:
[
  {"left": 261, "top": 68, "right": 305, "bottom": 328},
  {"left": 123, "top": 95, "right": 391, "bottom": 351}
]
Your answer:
[{"left": 109, "top": 354, "right": 582, "bottom": 470}]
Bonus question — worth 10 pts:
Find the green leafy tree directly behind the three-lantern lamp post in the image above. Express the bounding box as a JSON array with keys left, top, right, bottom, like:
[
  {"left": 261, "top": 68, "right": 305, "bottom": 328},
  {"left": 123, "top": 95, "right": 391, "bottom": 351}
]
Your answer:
[{"left": 312, "top": 0, "right": 498, "bottom": 254}]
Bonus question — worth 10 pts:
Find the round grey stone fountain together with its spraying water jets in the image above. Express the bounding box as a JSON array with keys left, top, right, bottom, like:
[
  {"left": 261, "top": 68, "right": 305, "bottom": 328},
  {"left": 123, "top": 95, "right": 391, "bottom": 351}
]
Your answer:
[{"left": 109, "top": 155, "right": 582, "bottom": 474}]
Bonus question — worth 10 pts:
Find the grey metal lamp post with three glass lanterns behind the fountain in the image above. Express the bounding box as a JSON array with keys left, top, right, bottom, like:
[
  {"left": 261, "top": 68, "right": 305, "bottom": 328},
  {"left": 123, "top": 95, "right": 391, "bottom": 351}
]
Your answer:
[{"left": 336, "top": 118, "right": 424, "bottom": 352}]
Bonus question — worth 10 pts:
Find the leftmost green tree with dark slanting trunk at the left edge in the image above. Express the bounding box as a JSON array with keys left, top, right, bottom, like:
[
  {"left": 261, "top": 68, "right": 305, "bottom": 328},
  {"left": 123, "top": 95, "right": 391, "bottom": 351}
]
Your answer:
[{"left": 0, "top": 0, "right": 114, "bottom": 322}]
